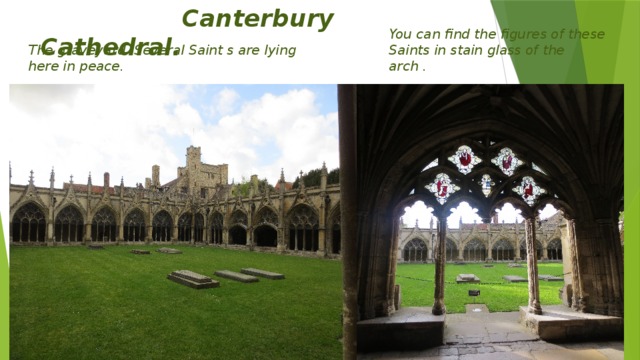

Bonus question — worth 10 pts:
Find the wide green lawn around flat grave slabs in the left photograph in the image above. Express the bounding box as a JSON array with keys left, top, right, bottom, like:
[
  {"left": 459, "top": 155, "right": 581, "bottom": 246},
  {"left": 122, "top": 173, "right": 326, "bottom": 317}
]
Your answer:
[{"left": 10, "top": 246, "right": 342, "bottom": 359}]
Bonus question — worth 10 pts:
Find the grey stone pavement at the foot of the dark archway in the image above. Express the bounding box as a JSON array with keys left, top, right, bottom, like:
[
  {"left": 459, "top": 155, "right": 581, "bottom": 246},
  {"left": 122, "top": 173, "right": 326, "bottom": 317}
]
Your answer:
[{"left": 358, "top": 304, "right": 624, "bottom": 360}]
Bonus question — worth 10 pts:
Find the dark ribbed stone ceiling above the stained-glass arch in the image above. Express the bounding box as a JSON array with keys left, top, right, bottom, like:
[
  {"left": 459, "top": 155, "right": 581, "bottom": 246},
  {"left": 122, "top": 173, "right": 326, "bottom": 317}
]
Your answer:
[{"left": 356, "top": 85, "right": 624, "bottom": 218}]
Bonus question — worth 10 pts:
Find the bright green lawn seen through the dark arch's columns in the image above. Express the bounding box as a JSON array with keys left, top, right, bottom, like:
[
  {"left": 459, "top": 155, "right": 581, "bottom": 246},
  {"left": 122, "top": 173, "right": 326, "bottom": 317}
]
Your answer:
[{"left": 396, "top": 263, "right": 564, "bottom": 313}]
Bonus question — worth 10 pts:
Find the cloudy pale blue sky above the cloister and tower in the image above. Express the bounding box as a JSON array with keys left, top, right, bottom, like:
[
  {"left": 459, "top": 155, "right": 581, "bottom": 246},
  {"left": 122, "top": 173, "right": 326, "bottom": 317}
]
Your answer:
[{"left": 5, "top": 84, "right": 339, "bottom": 187}]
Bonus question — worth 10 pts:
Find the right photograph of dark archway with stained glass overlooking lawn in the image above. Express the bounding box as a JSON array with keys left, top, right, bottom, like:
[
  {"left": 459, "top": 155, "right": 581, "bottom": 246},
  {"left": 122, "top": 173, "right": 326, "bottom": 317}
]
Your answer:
[{"left": 338, "top": 85, "right": 624, "bottom": 358}]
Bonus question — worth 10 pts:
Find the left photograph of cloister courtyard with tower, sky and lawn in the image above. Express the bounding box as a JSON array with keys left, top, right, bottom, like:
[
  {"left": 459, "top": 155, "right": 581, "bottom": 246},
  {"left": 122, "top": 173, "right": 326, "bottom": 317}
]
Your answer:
[{"left": 4, "top": 84, "right": 342, "bottom": 359}]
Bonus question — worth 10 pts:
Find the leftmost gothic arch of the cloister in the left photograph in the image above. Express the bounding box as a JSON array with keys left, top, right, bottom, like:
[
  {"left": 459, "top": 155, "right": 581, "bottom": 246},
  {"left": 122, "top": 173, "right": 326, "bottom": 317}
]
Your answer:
[{"left": 11, "top": 202, "right": 47, "bottom": 242}]
